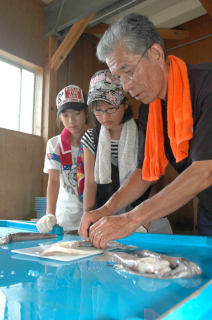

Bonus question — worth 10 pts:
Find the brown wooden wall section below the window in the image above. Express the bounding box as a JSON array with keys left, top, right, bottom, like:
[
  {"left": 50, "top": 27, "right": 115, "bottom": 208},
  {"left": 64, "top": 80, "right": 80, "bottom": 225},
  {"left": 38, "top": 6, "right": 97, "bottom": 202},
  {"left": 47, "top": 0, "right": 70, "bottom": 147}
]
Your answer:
[{"left": 0, "top": 128, "right": 43, "bottom": 220}]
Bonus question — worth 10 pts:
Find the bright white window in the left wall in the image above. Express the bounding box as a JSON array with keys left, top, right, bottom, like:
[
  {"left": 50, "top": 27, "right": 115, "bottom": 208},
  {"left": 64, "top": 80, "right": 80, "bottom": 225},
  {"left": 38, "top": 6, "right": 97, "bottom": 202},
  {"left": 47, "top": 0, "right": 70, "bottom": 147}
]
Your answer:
[{"left": 0, "top": 57, "right": 36, "bottom": 133}]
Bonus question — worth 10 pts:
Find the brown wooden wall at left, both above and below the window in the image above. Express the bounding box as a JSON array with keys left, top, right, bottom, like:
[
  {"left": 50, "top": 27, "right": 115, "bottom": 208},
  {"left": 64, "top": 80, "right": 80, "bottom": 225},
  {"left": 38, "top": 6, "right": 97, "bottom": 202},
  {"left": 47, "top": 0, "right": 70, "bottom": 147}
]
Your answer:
[{"left": 0, "top": 0, "right": 46, "bottom": 220}]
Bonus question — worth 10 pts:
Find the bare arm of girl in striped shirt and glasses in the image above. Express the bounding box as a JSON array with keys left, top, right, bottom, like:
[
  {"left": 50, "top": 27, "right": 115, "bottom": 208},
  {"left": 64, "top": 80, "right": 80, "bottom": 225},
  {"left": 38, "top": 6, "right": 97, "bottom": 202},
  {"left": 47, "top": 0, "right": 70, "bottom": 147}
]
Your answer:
[{"left": 83, "top": 146, "right": 97, "bottom": 212}]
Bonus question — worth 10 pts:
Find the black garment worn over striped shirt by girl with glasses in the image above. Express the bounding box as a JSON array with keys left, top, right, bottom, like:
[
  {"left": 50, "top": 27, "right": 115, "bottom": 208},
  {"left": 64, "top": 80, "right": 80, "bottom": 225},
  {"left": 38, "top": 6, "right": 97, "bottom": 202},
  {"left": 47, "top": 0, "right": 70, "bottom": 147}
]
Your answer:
[{"left": 94, "top": 127, "right": 151, "bottom": 209}]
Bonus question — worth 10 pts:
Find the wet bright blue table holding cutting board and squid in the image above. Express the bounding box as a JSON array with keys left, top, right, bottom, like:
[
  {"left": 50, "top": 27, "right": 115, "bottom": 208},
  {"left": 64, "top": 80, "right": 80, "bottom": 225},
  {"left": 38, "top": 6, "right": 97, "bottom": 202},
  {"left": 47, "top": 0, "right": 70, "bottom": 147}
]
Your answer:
[{"left": 0, "top": 221, "right": 212, "bottom": 320}]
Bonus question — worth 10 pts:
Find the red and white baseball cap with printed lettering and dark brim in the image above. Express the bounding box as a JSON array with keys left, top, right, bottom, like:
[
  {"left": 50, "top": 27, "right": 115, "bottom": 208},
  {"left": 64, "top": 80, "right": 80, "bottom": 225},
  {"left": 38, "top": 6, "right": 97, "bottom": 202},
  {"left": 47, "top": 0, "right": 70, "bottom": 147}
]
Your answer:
[{"left": 56, "top": 85, "right": 87, "bottom": 115}]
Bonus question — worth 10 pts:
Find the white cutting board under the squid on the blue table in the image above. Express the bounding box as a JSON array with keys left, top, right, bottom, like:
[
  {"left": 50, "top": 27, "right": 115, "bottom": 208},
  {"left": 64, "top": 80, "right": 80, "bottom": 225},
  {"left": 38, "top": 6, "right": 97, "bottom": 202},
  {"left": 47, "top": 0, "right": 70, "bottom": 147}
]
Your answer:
[{"left": 11, "top": 245, "right": 104, "bottom": 261}]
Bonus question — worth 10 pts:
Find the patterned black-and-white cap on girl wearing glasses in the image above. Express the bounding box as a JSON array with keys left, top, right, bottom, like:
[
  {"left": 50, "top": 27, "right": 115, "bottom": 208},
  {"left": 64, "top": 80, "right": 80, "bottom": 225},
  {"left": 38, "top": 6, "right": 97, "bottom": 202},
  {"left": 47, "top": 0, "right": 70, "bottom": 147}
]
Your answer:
[{"left": 88, "top": 70, "right": 126, "bottom": 106}]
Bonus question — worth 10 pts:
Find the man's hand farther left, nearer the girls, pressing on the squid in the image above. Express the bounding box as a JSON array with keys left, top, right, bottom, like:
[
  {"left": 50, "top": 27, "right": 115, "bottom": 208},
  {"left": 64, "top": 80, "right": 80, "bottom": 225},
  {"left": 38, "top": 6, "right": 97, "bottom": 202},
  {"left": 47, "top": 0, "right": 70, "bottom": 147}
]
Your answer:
[{"left": 78, "top": 206, "right": 110, "bottom": 240}]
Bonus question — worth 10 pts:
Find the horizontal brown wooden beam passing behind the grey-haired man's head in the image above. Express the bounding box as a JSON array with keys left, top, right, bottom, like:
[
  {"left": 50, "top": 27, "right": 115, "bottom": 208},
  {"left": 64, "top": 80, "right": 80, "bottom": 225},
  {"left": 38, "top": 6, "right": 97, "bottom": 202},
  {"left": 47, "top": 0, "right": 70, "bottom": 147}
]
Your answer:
[{"left": 83, "top": 23, "right": 190, "bottom": 40}]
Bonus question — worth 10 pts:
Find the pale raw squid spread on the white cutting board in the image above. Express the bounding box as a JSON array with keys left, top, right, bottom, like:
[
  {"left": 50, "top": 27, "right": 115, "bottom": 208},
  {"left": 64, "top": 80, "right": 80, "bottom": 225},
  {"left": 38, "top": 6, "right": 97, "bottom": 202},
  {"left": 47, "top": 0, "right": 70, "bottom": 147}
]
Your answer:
[{"left": 40, "top": 241, "right": 136, "bottom": 256}]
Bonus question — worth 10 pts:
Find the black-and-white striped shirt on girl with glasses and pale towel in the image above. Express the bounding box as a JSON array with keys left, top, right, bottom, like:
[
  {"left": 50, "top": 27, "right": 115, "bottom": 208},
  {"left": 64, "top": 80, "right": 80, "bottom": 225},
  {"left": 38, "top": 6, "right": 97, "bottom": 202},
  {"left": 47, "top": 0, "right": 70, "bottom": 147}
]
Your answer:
[{"left": 81, "top": 129, "right": 119, "bottom": 159}]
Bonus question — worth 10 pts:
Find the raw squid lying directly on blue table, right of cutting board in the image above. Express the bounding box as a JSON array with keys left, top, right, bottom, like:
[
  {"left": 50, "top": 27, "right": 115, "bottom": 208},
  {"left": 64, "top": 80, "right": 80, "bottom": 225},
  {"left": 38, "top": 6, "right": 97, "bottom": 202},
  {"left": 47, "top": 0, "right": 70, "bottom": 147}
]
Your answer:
[{"left": 94, "top": 250, "right": 202, "bottom": 279}]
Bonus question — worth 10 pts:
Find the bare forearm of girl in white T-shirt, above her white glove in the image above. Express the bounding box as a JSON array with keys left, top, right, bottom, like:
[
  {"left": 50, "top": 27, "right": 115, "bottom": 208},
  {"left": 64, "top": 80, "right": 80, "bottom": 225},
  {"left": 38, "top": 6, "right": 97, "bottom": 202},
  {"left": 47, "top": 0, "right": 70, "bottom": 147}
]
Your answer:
[{"left": 46, "top": 169, "right": 60, "bottom": 214}]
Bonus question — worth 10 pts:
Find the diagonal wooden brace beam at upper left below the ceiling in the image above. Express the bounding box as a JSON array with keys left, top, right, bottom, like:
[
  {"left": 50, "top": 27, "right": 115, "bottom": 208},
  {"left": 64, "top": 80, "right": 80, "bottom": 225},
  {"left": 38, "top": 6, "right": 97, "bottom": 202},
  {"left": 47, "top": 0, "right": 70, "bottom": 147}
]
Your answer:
[{"left": 51, "top": 13, "right": 95, "bottom": 71}]
